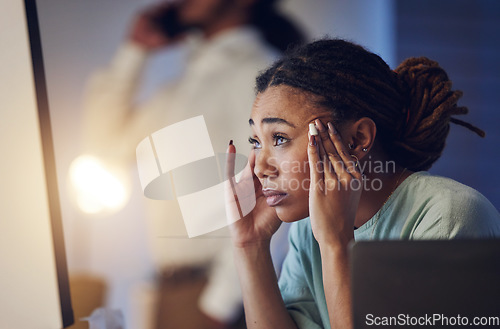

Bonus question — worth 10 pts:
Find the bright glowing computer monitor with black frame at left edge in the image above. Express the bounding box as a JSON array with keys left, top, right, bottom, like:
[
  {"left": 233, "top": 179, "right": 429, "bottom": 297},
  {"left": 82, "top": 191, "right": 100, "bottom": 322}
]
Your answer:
[{"left": 0, "top": 0, "right": 74, "bottom": 329}]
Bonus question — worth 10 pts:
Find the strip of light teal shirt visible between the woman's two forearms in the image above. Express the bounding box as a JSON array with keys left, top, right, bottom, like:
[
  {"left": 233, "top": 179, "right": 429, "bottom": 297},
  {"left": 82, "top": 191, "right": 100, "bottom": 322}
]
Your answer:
[{"left": 279, "top": 223, "right": 322, "bottom": 329}]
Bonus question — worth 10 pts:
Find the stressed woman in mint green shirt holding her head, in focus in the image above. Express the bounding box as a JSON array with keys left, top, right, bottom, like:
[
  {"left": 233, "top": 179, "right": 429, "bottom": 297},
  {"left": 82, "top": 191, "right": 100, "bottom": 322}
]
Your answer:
[{"left": 228, "top": 40, "right": 500, "bottom": 329}]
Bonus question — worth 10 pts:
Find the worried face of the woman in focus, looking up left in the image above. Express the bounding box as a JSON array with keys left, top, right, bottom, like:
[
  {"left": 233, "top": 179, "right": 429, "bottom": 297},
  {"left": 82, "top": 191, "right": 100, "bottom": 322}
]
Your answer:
[{"left": 249, "top": 86, "right": 330, "bottom": 222}]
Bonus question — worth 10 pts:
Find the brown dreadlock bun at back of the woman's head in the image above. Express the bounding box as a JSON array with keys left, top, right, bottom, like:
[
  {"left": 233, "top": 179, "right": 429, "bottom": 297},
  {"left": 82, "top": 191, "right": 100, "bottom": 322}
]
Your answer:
[{"left": 395, "top": 57, "right": 485, "bottom": 170}]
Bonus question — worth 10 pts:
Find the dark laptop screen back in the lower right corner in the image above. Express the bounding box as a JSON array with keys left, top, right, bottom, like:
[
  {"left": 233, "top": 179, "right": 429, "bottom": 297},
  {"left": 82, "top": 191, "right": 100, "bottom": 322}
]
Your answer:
[{"left": 350, "top": 239, "right": 500, "bottom": 328}]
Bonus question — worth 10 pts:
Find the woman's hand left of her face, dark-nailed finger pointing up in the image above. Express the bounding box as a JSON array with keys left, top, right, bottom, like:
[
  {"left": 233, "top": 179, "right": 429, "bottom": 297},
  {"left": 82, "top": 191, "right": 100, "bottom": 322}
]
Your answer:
[{"left": 225, "top": 144, "right": 281, "bottom": 247}]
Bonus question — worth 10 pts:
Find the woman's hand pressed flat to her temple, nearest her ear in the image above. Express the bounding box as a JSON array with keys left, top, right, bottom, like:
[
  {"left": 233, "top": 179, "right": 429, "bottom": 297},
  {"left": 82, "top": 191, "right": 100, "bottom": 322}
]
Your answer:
[{"left": 308, "top": 119, "right": 363, "bottom": 247}]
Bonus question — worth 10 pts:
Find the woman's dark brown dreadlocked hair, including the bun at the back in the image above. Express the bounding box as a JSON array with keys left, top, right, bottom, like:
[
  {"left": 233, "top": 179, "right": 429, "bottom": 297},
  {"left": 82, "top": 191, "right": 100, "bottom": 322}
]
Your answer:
[{"left": 256, "top": 39, "right": 485, "bottom": 171}]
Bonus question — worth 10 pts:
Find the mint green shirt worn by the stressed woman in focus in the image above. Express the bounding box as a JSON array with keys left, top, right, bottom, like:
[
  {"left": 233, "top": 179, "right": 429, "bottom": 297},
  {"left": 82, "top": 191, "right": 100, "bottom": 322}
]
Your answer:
[{"left": 279, "top": 172, "right": 500, "bottom": 329}]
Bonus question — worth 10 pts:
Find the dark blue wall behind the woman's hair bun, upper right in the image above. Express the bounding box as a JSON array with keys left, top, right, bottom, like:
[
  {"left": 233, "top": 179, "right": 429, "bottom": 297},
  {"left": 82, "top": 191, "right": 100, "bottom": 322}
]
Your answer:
[{"left": 396, "top": 0, "right": 500, "bottom": 209}]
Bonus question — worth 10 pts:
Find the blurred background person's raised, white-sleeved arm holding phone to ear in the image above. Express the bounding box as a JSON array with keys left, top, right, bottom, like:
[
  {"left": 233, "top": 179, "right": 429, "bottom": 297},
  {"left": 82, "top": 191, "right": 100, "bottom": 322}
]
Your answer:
[{"left": 83, "top": 7, "right": 180, "bottom": 161}]
